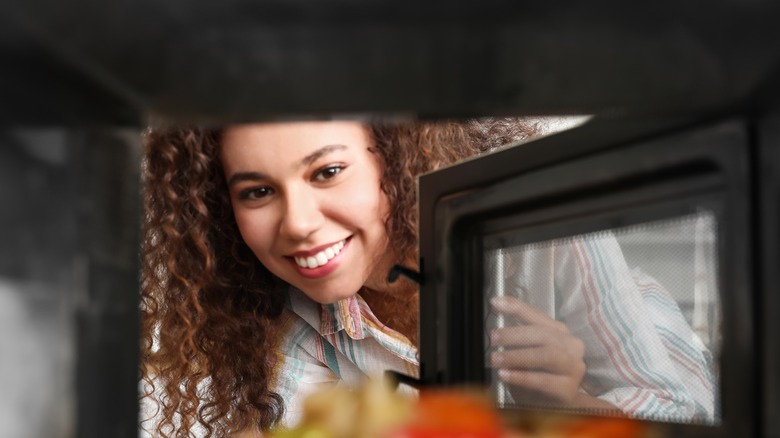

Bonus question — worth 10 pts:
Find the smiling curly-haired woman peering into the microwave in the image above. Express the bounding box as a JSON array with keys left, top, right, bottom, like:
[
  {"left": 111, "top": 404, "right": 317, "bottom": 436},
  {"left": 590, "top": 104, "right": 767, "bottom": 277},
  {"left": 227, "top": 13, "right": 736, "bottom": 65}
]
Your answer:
[{"left": 142, "top": 121, "right": 712, "bottom": 436}]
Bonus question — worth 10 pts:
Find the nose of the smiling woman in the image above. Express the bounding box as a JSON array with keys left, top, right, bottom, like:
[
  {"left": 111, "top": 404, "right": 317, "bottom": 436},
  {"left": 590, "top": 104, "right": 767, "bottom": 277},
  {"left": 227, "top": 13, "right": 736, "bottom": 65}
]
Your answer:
[{"left": 279, "top": 188, "right": 325, "bottom": 240}]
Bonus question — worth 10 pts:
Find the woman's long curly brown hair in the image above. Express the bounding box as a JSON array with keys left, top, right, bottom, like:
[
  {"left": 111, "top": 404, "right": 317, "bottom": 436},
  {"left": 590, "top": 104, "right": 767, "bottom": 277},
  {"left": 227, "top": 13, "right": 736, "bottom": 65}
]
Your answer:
[{"left": 141, "top": 119, "right": 537, "bottom": 437}]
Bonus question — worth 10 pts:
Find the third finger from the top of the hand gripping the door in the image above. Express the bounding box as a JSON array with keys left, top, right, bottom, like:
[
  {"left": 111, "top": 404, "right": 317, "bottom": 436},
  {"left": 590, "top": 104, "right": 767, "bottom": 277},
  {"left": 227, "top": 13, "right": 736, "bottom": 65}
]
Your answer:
[{"left": 490, "top": 346, "right": 585, "bottom": 372}]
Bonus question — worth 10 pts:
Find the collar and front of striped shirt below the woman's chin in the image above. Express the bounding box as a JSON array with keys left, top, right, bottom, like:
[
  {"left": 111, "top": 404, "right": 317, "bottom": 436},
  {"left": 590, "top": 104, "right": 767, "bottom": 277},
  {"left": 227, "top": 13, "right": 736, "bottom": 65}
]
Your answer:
[{"left": 273, "top": 287, "right": 419, "bottom": 426}]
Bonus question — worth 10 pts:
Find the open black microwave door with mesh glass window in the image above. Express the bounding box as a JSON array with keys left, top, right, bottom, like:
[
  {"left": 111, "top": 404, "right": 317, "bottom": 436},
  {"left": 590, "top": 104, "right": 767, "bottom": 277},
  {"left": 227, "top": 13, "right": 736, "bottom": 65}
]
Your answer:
[{"left": 419, "top": 119, "right": 759, "bottom": 436}]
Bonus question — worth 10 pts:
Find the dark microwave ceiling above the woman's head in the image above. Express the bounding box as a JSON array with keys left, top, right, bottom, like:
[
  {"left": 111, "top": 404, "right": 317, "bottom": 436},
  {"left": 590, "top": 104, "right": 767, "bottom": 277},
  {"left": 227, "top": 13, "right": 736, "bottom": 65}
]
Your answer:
[{"left": 0, "top": 0, "right": 780, "bottom": 125}]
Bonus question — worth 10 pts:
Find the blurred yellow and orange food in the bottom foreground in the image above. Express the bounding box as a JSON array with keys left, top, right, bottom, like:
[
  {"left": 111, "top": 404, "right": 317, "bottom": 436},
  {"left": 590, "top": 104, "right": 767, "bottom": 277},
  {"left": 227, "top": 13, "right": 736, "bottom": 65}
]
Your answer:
[{"left": 269, "top": 379, "right": 644, "bottom": 438}]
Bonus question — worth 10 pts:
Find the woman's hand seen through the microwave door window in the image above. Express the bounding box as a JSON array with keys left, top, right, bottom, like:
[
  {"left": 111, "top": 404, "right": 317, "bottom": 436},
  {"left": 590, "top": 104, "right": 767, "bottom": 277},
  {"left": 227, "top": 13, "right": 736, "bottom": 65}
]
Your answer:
[{"left": 490, "top": 296, "right": 585, "bottom": 406}]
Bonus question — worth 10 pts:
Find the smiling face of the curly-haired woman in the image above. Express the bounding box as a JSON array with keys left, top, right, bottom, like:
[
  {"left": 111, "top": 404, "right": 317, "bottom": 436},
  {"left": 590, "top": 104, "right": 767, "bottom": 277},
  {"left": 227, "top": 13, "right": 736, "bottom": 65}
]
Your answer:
[{"left": 221, "top": 122, "right": 392, "bottom": 303}]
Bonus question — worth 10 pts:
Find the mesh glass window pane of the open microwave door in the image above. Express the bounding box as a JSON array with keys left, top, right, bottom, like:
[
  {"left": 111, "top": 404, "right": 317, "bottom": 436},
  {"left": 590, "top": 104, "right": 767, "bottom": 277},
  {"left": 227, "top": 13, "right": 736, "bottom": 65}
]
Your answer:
[{"left": 484, "top": 211, "right": 721, "bottom": 424}]
